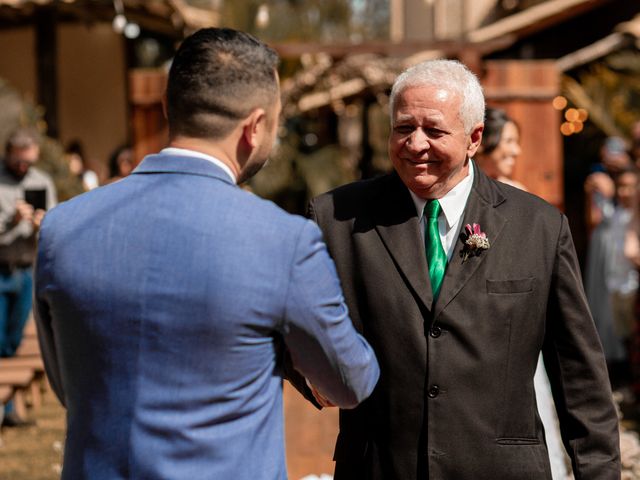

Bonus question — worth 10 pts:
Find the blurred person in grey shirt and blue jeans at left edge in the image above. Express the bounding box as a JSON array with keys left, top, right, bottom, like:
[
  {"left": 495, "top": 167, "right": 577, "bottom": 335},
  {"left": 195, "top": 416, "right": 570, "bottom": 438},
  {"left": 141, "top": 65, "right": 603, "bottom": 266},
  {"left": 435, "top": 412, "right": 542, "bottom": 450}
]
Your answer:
[{"left": 0, "top": 129, "right": 57, "bottom": 427}]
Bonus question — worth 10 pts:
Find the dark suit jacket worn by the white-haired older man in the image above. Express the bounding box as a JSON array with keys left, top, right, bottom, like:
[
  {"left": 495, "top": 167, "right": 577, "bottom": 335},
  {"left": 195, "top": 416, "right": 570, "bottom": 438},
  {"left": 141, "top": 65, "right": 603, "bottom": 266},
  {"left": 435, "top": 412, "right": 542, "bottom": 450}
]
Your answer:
[{"left": 310, "top": 163, "right": 620, "bottom": 480}]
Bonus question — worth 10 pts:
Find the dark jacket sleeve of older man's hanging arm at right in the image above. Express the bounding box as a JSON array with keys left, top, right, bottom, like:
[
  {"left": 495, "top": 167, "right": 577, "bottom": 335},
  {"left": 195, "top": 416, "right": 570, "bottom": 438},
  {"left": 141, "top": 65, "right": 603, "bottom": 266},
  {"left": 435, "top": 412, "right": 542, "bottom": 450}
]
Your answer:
[{"left": 543, "top": 215, "right": 621, "bottom": 480}]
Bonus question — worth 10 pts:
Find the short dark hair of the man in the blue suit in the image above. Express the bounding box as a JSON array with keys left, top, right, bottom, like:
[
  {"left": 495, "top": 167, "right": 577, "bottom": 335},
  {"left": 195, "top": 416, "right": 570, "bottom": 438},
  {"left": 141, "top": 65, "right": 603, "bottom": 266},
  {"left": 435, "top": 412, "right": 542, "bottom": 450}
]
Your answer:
[{"left": 167, "top": 28, "right": 278, "bottom": 139}]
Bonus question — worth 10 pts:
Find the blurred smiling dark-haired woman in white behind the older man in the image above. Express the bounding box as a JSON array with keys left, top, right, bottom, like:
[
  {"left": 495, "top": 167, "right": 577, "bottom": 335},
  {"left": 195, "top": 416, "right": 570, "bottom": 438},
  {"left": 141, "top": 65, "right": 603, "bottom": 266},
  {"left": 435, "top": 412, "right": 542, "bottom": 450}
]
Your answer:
[{"left": 474, "top": 107, "right": 569, "bottom": 480}]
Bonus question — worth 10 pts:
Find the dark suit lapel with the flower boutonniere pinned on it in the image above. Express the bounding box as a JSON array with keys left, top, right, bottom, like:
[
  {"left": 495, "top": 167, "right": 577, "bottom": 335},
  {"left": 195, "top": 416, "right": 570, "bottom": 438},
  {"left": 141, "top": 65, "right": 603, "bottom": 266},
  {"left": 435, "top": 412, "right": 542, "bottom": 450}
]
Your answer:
[{"left": 433, "top": 164, "right": 507, "bottom": 320}]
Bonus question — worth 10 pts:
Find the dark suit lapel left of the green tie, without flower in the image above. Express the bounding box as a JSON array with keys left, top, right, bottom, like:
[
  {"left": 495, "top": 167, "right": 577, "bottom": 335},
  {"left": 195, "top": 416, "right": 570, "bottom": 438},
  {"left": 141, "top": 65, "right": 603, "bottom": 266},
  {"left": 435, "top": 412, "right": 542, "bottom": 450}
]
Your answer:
[{"left": 374, "top": 174, "right": 433, "bottom": 310}]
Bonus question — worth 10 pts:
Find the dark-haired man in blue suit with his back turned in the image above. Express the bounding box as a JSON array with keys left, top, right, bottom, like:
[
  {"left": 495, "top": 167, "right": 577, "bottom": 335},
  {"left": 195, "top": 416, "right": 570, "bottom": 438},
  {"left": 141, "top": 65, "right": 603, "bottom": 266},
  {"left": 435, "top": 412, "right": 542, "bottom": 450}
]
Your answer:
[{"left": 35, "top": 29, "right": 379, "bottom": 480}]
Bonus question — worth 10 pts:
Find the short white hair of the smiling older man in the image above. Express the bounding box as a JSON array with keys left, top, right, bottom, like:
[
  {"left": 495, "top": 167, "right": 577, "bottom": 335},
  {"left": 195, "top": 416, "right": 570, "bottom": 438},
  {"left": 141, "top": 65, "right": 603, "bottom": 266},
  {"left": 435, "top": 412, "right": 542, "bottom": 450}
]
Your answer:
[{"left": 389, "top": 60, "right": 484, "bottom": 133}]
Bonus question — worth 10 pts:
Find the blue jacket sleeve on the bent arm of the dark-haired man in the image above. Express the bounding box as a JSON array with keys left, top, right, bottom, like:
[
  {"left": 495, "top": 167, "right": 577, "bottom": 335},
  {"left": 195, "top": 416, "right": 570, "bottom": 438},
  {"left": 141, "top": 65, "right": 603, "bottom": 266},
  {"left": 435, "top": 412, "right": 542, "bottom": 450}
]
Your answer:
[{"left": 283, "top": 221, "right": 380, "bottom": 408}]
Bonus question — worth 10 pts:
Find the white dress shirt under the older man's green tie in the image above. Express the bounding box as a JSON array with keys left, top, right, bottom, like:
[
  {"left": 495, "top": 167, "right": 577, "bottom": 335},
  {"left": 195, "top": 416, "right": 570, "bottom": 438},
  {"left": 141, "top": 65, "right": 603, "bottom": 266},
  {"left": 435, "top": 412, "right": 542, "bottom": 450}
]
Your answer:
[{"left": 409, "top": 160, "right": 473, "bottom": 260}]
